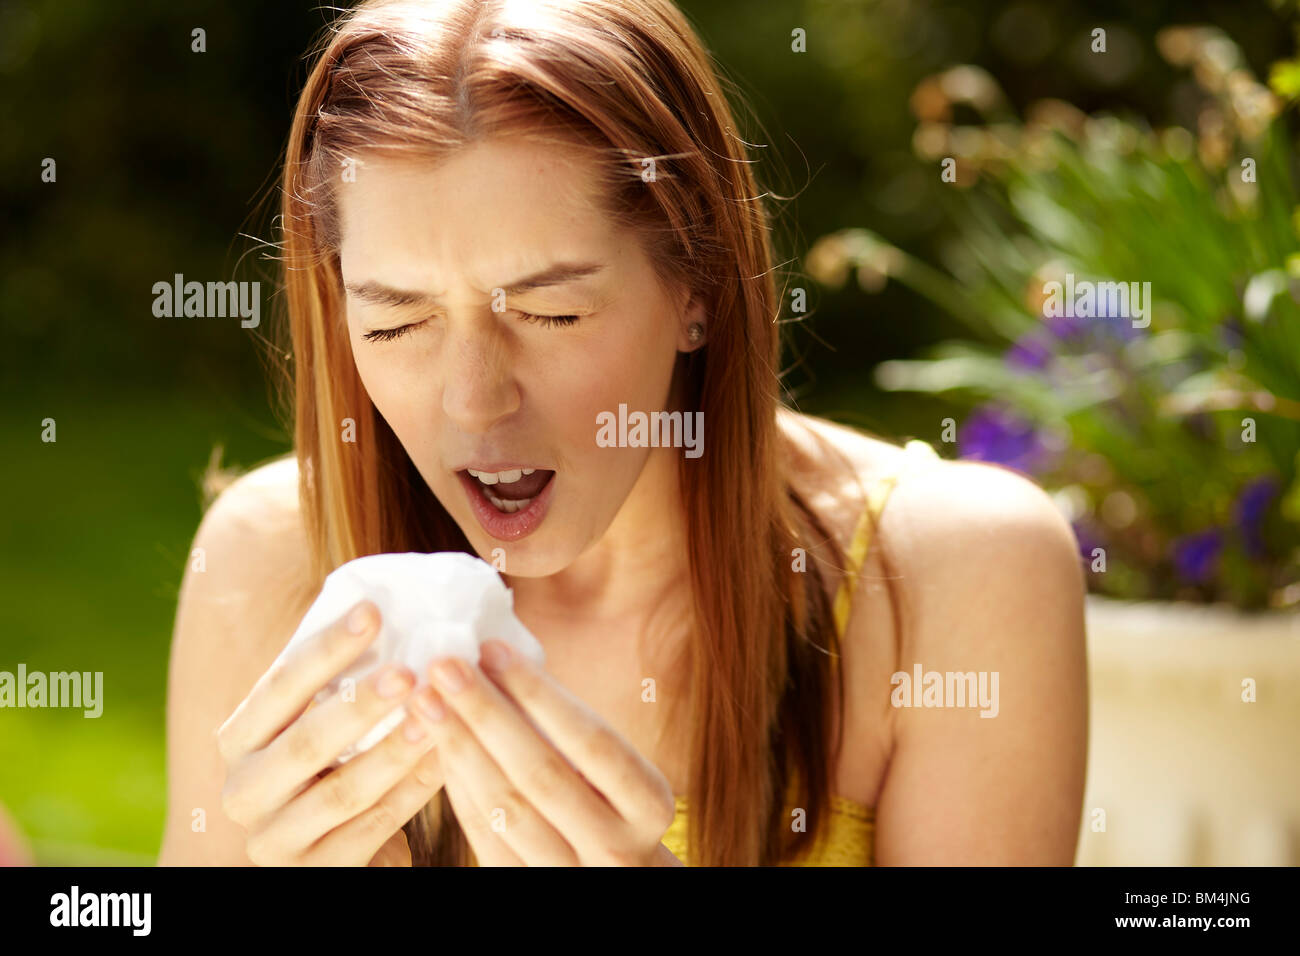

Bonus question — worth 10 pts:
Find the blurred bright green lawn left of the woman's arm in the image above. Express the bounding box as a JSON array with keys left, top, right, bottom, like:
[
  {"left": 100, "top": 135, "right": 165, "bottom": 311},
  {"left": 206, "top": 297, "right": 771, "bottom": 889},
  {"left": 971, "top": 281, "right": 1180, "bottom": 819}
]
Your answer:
[{"left": 0, "top": 389, "right": 287, "bottom": 865}]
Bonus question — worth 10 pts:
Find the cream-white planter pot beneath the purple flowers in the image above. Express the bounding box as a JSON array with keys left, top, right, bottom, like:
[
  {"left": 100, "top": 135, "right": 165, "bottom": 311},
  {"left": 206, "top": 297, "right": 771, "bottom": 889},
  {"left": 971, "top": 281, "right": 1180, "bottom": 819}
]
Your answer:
[{"left": 1075, "top": 594, "right": 1300, "bottom": 866}]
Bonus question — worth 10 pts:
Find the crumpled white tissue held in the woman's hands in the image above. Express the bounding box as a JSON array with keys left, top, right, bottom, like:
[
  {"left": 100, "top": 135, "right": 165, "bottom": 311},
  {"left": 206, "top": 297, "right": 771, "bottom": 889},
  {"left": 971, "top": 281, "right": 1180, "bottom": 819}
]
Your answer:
[{"left": 281, "top": 551, "right": 545, "bottom": 766}]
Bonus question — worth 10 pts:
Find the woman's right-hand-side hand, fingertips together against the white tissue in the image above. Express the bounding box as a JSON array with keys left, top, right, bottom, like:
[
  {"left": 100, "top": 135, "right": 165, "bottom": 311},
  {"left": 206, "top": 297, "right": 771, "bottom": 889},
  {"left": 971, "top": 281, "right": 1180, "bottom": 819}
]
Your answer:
[{"left": 420, "top": 641, "right": 681, "bottom": 866}]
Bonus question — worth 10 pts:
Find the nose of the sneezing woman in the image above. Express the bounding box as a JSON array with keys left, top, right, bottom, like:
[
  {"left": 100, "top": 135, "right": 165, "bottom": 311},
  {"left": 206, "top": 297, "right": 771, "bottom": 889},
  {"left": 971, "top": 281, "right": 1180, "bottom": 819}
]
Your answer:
[{"left": 441, "top": 319, "right": 520, "bottom": 433}]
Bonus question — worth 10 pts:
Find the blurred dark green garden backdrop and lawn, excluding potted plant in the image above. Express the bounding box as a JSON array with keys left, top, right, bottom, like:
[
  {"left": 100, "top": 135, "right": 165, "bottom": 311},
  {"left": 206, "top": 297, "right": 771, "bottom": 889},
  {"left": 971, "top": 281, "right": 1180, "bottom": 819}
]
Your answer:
[{"left": 0, "top": 0, "right": 1291, "bottom": 864}]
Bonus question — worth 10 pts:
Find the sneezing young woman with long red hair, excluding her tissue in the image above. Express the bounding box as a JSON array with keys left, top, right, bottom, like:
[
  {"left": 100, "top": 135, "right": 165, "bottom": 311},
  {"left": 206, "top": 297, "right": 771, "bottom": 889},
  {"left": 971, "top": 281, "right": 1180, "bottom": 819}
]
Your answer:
[{"left": 160, "top": 0, "right": 1087, "bottom": 865}]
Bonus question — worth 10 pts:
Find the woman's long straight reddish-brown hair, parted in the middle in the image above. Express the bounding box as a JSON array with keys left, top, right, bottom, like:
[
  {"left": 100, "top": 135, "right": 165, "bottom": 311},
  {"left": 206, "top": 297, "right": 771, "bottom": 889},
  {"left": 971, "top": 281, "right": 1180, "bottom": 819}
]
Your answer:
[{"left": 281, "top": 0, "right": 844, "bottom": 865}]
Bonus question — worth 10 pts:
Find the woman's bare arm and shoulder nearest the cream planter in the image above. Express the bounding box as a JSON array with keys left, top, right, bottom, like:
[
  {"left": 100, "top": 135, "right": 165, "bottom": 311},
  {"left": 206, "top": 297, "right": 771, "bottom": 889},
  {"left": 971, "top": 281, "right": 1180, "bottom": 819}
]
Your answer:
[{"left": 872, "top": 462, "right": 1088, "bottom": 865}]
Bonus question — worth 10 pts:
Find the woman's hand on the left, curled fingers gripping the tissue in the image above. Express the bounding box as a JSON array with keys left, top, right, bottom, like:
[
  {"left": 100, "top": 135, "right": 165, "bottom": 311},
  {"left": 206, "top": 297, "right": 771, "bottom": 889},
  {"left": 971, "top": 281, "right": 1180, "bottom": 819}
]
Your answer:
[{"left": 217, "top": 601, "right": 442, "bottom": 866}]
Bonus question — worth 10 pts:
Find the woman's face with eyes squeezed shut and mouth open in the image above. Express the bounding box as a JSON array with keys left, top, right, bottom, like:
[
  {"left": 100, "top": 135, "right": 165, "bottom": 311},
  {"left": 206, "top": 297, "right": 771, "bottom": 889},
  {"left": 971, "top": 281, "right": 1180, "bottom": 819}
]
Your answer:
[{"left": 338, "top": 139, "right": 698, "bottom": 576}]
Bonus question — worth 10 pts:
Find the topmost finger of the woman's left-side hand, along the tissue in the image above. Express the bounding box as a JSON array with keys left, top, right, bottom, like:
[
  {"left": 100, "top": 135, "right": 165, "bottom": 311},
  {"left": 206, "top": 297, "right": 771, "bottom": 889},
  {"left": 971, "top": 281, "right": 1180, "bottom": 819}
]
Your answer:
[{"left": 217, "top": 601, "right": 380, "bottom": 765}]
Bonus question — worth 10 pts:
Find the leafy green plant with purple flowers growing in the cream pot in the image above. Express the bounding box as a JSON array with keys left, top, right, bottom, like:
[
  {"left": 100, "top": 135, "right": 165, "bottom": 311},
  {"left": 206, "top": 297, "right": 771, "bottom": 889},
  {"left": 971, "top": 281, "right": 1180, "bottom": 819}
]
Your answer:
[{"left": 809, "top": 27, "right": 1300, "bottom": 607}]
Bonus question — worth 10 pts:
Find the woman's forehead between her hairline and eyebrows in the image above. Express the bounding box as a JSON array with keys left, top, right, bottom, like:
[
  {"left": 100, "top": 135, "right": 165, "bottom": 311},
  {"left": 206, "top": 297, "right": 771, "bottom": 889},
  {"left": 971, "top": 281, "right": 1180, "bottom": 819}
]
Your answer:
[{"left": 338, "top": 139, "right": 615, "bottom": 289}]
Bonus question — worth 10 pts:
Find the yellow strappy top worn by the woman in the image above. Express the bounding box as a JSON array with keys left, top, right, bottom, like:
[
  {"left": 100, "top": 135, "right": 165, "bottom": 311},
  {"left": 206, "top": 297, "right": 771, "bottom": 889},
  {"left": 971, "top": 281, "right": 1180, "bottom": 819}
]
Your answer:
[{"left": 663, "top": 438, "right": 939, "bottom": 866}]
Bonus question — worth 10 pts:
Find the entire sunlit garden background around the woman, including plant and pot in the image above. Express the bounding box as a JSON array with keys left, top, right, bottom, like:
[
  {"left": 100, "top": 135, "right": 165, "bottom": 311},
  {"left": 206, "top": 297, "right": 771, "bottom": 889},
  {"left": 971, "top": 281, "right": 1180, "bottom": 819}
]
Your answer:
[{"left": 0, "top": 0, "right": 1300, "bottom": 864}]
